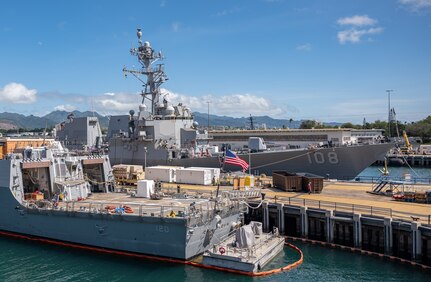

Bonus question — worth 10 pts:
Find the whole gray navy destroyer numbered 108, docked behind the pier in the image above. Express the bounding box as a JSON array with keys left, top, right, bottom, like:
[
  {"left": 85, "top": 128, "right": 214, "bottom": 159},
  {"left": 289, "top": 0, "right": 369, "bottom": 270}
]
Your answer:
[{"left": 107, "top": 30, "right": 393, "bottom": 178}]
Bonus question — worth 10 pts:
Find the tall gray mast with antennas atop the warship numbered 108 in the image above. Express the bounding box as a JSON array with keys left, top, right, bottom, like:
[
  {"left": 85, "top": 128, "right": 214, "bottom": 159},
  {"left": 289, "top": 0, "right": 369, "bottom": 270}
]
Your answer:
[{"left": 123, "top": 28, "right": 168, "bottom": 115}]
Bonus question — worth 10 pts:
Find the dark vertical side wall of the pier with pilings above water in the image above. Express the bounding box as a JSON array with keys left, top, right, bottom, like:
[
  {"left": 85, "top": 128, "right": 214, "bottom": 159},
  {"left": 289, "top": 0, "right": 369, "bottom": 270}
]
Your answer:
[{"left": 246, "top": 198, "right": 431, "bottom": 265}]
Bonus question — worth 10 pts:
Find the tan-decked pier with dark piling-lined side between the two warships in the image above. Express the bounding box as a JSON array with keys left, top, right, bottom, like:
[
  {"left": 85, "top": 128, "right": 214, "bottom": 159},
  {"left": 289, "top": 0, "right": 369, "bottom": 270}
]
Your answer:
[{"left": 161, "top": 181, "right": 431, "bottom": 266}]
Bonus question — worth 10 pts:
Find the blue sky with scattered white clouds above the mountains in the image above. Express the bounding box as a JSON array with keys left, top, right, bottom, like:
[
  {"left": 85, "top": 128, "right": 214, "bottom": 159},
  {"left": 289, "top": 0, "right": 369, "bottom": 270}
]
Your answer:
[{"left": 0, "top": 0, "right": 431, "bottom": 123}]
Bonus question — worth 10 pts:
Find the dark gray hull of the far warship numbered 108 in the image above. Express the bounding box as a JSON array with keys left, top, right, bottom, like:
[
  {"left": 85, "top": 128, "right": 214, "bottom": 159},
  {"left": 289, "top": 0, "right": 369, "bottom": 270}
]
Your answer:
[{"left": 109, "top": 138, "right": 393, "bottom": 179}]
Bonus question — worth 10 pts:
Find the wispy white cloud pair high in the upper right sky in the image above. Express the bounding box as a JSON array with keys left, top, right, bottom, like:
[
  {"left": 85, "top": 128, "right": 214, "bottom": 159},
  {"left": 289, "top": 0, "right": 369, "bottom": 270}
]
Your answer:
[{"left": 337, "top": 15, "right": 383, "bottom": 44}]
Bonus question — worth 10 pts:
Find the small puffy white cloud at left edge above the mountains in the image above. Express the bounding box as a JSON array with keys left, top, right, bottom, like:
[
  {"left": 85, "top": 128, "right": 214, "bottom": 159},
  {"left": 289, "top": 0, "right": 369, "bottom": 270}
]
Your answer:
[{"left": 0, "top": 82, "right": 37, "bottom": 104}]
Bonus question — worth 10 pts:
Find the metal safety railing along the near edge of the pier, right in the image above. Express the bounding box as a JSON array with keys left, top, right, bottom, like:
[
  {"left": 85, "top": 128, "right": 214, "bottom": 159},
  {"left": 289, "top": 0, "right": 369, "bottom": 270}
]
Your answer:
[{"left": 268, "top": 196, "right": 431, "bottom": 224}]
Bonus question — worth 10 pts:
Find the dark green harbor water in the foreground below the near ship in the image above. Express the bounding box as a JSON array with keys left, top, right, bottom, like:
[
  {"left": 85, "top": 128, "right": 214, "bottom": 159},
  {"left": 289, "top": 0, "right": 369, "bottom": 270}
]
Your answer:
[{"left": 0, "top": 237, "right": 431, "bottom": 282}]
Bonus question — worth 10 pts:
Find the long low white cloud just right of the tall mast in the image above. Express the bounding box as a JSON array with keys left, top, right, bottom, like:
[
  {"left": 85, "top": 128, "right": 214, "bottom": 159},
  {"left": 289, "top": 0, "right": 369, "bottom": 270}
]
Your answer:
[{"left": 162, "top": 89, "right": 285, "bottom": 117}]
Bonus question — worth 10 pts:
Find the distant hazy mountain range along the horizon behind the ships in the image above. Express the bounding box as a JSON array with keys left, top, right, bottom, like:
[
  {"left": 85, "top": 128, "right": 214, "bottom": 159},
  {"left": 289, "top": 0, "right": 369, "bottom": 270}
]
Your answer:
[{"left": 0, "top": 111, "right": 340, "bottom": 130}]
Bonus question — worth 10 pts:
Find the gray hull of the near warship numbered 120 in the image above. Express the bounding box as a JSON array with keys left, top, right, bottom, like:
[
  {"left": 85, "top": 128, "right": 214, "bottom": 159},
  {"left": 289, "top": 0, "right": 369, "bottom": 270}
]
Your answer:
[{"left": 0, "top": 156, "right": 240, "bottom": 260}]
